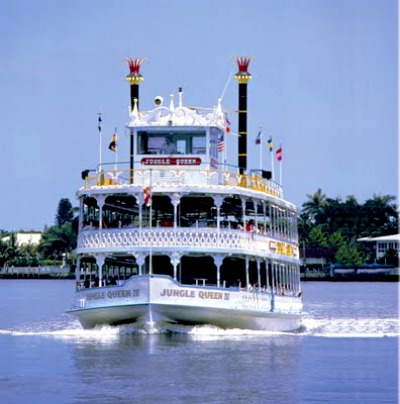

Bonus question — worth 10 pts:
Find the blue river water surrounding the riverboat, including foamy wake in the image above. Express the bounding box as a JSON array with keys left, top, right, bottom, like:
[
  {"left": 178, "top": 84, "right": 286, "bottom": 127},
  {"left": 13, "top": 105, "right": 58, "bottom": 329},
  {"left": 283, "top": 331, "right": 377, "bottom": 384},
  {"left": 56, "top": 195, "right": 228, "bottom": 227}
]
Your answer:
[{"left": 0, "top": 280, "right": 399, "bottom": 404}]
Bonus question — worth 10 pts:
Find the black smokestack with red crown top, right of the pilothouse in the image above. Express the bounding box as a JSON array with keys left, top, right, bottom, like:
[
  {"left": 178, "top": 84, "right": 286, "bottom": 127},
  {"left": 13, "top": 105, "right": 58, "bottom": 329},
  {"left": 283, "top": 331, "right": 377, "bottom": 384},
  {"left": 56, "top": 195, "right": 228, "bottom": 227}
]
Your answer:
[{"left": 234, "top": 56, "right": 253, "bottom": 174}]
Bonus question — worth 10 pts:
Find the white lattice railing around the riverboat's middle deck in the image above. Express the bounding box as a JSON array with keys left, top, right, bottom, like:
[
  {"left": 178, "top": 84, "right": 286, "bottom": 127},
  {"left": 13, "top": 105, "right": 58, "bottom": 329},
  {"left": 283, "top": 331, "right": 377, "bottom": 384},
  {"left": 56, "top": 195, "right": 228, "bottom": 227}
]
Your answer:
[{"left": 77, "top": 227, "right": 298, "bottom": 257}]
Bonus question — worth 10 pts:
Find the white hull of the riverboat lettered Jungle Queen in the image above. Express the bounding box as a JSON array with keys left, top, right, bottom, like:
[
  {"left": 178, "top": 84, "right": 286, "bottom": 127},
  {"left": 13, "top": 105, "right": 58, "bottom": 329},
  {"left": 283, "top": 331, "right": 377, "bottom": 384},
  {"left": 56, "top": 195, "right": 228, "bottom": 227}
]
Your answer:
[{"left": 70, "top": 275, "right": 302, "bottom": 331}]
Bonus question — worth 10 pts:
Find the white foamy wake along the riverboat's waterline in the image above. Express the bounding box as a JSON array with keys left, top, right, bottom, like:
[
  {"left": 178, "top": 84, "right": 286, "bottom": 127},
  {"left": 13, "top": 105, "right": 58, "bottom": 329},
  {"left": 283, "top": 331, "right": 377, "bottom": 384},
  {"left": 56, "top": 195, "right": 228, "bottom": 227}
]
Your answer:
[{"left": 0, "top": 318, "right": 400, "bottom": 343}]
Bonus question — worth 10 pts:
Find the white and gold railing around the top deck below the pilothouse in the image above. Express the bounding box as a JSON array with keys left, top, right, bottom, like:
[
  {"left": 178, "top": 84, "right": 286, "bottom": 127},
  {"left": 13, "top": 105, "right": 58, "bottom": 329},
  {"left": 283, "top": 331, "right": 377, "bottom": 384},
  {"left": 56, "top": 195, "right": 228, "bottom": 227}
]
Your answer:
[{"left": 85, "top": 166, "right": 283, "bottom": 198}]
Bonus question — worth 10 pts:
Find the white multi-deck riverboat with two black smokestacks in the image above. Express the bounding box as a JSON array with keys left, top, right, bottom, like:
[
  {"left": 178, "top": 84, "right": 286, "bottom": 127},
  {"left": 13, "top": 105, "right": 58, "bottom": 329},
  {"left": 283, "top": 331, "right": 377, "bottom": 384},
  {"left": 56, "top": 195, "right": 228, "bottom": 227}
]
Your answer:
[{"left": 69, "top": 58, "right": 302, "bottom": 331}]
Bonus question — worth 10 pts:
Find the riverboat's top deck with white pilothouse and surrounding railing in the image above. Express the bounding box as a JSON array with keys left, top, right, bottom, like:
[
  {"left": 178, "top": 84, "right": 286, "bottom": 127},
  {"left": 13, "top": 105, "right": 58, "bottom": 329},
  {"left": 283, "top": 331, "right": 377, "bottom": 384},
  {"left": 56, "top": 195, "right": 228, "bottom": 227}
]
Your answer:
[{"left": 81, "top": 91, "right": 283, "bottom": 204}]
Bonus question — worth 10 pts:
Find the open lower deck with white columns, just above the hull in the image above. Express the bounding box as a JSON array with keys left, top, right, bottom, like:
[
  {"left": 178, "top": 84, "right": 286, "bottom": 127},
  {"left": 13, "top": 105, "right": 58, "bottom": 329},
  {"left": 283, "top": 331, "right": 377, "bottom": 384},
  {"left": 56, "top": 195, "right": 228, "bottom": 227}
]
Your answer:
[{"left": 76, "top": 253, "right": 301, "bottom": 296}]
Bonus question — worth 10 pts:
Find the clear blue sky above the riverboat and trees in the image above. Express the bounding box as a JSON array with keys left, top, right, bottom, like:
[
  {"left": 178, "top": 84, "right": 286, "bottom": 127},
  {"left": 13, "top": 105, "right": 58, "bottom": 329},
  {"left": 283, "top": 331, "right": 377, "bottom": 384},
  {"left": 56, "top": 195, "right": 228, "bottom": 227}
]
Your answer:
[{"left": 0, "top": 0, "right": 398, "bottom": 230}]
